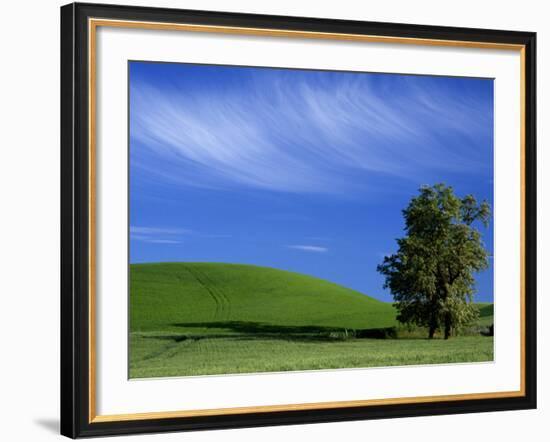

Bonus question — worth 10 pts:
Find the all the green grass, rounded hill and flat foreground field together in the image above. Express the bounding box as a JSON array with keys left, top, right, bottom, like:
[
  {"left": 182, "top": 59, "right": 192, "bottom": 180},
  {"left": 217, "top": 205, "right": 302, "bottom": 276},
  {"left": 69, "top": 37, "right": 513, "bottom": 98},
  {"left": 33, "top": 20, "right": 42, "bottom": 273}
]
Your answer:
[{"left": 130, "top": 263, "right": 493, "bottom": 378}]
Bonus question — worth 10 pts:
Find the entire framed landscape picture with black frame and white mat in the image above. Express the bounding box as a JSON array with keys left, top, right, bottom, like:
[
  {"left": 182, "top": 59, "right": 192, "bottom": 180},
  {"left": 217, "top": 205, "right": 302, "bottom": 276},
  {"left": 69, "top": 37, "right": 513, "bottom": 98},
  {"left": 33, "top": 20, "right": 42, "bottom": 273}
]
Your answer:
[{"left": 61, "top": 4, "right": 536, "bottom": 438}]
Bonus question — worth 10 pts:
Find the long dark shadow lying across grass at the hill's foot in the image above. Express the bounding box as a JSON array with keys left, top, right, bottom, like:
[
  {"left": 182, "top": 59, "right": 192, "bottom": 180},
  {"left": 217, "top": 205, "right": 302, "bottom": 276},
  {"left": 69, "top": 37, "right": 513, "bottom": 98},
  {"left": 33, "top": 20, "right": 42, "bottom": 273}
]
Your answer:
[{"left": 144, "top": 321, "right": 397, "bottom": 342}]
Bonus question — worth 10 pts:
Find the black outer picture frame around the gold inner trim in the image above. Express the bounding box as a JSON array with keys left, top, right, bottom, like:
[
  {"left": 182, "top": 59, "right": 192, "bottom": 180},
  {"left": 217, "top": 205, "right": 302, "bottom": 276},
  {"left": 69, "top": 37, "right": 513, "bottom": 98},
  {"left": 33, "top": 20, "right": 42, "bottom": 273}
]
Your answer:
[{"left": 61, "top": 3, "right": 537, "bottom": 438}]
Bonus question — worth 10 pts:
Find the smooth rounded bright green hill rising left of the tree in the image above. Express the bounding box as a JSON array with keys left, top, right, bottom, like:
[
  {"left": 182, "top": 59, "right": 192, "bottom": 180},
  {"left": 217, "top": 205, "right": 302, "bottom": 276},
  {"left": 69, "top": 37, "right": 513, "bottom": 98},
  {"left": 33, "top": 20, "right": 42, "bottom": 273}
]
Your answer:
[{"left": 130, "top": 263, "right": 396, "bottom": 332}]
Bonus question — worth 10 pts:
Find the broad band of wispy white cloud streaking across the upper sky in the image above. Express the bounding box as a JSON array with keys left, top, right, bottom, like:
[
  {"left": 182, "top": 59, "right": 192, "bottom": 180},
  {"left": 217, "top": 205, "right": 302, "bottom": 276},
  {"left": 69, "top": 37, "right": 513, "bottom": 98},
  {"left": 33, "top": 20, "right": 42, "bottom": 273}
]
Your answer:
[{"left": 130, "top": 65, "right": 492, "bottom": 194}]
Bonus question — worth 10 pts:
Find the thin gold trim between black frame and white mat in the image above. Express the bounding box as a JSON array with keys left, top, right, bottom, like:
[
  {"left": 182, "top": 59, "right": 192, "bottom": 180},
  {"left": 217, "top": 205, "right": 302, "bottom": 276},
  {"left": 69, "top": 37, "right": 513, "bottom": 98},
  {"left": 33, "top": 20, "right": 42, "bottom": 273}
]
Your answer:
[{"left": 88, "top": 18, "right": 526, "bottom": 423}]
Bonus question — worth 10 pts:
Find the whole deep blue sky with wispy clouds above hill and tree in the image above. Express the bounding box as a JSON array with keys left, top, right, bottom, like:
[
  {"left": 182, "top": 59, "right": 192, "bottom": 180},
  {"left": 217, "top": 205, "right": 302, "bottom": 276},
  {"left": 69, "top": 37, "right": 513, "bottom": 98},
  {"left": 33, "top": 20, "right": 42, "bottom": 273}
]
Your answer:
[{"left": 129, "top": 62, "right": 493, "bottom": 301}]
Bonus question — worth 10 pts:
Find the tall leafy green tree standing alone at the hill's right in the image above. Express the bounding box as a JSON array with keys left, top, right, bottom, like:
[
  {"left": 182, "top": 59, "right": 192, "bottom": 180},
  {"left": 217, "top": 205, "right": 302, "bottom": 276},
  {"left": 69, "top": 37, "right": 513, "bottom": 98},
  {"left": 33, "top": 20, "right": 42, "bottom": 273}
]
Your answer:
[{"left": 378, "top": 184, "right": 490, "bottom": 339}]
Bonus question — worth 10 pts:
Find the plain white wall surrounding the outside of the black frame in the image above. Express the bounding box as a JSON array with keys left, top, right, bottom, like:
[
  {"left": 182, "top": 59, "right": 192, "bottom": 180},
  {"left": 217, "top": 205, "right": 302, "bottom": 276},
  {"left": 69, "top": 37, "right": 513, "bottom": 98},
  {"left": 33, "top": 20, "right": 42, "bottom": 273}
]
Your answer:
[{"left": 0, "top": 0, "right": 550, "bottom": 442}]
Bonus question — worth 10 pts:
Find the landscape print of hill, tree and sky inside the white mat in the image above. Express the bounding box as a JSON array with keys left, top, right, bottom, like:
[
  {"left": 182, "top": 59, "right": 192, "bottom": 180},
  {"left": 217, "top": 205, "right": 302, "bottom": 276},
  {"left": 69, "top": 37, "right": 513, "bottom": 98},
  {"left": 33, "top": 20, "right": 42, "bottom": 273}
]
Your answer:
[{"left": 132, "top": 61, "right": 494, "bottom": 378}]
